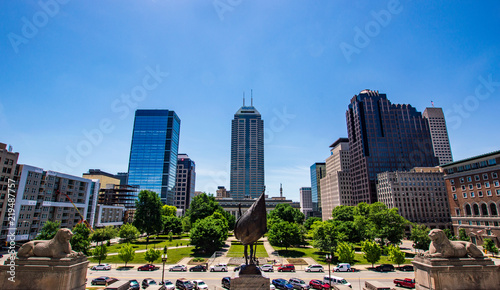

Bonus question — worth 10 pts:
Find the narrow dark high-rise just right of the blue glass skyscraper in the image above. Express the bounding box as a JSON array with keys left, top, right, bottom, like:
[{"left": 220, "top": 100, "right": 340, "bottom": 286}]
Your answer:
[{"left": 174, "top": 154, "right": 196, "bottom": 213}]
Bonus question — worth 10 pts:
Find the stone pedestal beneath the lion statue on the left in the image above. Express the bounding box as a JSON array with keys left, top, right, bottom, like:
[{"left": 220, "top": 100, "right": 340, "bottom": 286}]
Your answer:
[{"left": 0, "top": 256, "right": 89, "bottom": 290}]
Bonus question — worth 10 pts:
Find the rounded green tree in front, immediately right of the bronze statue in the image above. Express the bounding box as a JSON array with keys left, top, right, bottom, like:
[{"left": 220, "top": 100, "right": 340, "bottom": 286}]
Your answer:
[{"left": 267, "top": 221, "right": 302, "bottom": 250}]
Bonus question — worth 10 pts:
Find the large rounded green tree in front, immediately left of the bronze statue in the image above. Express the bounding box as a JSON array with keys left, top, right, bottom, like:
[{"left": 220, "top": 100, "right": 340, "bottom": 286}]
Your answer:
[{"left": 189, "top": 216, "right": 227, "bottom": 253}]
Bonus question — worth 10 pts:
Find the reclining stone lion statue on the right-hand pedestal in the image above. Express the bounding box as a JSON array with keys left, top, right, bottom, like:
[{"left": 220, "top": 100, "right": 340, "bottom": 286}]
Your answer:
[{"left": 423, "top": 229, "right": 483, "bottom": 258}]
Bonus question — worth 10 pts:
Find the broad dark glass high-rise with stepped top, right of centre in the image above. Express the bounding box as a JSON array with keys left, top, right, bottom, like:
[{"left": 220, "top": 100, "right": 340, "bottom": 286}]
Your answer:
[{"left": 346, "top": 90, "right": 439, "bottom": 204}]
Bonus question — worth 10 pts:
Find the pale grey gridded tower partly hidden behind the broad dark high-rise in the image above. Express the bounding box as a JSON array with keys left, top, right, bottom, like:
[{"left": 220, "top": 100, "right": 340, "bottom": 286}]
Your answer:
[{"left": 422, "top": 107, "right": 453, "bottom": 165}]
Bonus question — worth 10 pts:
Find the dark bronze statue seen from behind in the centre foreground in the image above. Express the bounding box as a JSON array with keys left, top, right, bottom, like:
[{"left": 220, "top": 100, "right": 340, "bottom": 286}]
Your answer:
[{"left": 234, "top": 187, "right": 267, "bottom": 265}]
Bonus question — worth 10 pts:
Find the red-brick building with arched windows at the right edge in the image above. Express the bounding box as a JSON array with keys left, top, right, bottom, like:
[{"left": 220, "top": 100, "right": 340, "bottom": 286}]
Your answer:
[{"left": 442, "top": 151, "right": 500, "bottom": 247}]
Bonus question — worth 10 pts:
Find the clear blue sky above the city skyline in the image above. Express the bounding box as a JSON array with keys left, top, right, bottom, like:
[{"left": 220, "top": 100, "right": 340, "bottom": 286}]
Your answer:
[{"left": 0, "top": 0, "right": 500, "bottom": 200}]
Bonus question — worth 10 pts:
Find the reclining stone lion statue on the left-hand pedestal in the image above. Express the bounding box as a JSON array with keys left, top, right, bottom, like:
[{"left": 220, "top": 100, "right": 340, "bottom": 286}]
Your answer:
[{"left": 17, "top": 228, "right": 83, "bottom": 259}]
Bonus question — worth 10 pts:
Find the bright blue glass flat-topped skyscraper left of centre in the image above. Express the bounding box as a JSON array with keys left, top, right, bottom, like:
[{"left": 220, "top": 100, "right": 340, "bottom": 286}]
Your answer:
[{"left": 128, "top": 110, "right": 181, "bottom": 205}]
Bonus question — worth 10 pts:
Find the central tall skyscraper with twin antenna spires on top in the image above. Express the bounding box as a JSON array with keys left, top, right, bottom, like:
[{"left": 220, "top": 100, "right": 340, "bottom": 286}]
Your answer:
[{"left": 230, "top": 99, "right": 264, "bottom": 198}]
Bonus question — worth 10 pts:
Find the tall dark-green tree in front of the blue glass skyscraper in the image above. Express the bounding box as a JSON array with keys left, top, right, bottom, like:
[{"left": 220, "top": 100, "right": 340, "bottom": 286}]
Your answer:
[{"left": 134, "top": 190, "right": 163, "bottom": 248}]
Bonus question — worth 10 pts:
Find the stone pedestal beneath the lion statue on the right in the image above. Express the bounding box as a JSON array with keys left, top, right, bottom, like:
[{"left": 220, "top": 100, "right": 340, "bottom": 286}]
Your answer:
[{"left": 412, "top": 257, "right": 500, "bottom": 290}]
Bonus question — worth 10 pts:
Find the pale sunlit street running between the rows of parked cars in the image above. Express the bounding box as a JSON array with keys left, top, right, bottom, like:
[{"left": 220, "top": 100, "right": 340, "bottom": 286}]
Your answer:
[{"left": 87, "top": 266, "right": 414, "bottom": 290}]
